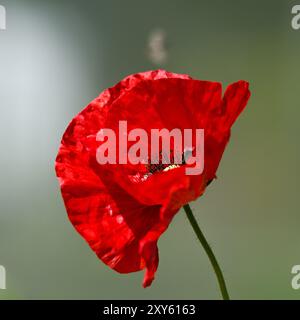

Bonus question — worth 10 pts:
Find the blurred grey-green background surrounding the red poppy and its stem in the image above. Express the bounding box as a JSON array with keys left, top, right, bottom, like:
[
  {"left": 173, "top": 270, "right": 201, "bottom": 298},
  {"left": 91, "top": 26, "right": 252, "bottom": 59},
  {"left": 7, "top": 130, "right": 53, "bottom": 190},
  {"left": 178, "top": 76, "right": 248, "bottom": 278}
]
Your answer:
[{"left": 0, "top": 0, "right": 300, "bottom": 299}]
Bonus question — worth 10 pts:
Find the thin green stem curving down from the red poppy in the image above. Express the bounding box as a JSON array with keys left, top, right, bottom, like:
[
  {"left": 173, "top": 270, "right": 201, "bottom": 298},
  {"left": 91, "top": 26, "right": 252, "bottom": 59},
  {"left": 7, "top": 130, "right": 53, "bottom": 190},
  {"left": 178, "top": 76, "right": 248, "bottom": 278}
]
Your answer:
[{"left": 183, "top": 204, "right": 229, "bottom": 300}]
